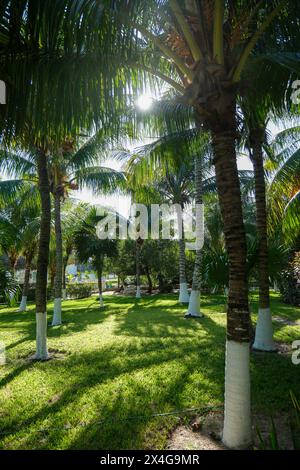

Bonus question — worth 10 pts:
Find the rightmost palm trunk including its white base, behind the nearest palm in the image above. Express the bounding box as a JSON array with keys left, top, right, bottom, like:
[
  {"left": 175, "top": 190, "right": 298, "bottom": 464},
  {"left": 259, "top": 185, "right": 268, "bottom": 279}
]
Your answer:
[{"left": 250, "top": 129, "right": 275, "bottom": 351}]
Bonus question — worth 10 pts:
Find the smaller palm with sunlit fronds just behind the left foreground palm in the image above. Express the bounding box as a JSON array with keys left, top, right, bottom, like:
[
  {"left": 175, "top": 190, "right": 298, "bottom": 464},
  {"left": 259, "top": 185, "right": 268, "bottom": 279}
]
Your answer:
[{"left": 0, "top": 140, "right": 124, "bottom": 326}]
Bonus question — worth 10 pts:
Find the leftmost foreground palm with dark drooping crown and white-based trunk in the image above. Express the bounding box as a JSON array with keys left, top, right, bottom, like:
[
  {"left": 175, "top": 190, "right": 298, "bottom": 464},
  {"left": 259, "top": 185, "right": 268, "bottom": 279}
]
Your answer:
[{"left": 0, "top": 0, "right": 123, "bottom": 360}]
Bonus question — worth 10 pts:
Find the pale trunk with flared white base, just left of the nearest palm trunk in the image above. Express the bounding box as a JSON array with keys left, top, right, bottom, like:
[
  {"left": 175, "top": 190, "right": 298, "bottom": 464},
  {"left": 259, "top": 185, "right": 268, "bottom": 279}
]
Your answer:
[{"left": 185, "top": 157, "right": 203, "bottom": 318}]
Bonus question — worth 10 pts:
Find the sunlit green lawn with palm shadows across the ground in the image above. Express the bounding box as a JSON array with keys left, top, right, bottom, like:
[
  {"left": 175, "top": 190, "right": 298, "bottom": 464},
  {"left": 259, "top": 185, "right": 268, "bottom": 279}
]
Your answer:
[{"left": 0, "top": 295, "right": 300, "bottom": 449}]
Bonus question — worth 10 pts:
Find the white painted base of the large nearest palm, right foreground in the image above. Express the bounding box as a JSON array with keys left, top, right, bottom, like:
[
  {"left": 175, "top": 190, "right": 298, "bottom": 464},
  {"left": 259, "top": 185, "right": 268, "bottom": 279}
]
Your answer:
[{"left": 222, "top": 340, "right": 252, "bottom": 449}]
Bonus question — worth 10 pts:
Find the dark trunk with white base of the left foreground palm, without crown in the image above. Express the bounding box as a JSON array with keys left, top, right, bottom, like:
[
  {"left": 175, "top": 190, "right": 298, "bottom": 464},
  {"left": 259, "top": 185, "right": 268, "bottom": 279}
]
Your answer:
[{"left": 35, "top": 151, "right": 51, "bottom": 360}]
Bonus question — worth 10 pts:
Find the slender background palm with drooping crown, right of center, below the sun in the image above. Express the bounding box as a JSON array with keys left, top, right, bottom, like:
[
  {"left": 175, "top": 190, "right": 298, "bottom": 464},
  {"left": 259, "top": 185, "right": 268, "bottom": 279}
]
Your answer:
[{"left": 123, "top": 128, "right": 211, "bottom": 308}]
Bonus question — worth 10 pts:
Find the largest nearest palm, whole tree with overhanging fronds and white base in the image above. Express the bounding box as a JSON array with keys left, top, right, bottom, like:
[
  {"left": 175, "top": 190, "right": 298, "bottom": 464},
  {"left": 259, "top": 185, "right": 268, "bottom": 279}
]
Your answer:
[{"left": 2, "top": 0, "right": 299, "bottom": 447}]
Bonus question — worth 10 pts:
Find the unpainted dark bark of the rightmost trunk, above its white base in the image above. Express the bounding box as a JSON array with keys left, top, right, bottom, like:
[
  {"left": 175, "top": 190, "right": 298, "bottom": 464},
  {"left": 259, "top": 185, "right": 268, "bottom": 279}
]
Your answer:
[{"left": 250, "top": 129, "right": 270, "bottom": 309}]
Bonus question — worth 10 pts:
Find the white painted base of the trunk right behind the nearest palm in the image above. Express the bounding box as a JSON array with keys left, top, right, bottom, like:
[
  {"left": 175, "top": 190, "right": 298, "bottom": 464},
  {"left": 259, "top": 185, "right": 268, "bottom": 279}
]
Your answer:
[{"left": 253, "top": 308, "right": 276, "bottom": 351}]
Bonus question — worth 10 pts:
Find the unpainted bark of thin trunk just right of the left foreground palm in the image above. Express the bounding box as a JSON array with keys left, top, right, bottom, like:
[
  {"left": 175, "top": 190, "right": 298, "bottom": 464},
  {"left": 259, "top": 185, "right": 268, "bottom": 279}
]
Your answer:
[{"left": 54, "top": 190, "right": 63, "bottom": 299}]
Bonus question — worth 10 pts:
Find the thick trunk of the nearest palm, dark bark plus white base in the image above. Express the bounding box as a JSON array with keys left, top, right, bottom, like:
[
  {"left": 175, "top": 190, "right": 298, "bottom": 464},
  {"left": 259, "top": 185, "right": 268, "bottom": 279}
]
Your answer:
[{"left": 210, "top": 109, "right": 251, "bottom": 448}]
